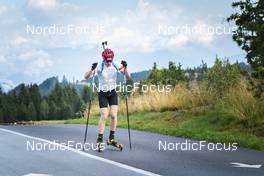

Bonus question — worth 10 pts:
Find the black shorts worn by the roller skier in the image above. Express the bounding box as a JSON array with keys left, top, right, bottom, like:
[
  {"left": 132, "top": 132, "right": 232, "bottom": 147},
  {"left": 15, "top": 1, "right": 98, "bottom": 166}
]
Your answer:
[{"left": 98, "top": 89, "right": 118, "bottom": 108}]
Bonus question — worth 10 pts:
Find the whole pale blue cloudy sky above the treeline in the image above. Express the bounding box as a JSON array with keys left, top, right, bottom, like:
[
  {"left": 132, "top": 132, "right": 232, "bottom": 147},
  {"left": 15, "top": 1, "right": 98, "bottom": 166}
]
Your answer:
[{"left": 0, "top": 0, "right": 245, "bottom": 90}]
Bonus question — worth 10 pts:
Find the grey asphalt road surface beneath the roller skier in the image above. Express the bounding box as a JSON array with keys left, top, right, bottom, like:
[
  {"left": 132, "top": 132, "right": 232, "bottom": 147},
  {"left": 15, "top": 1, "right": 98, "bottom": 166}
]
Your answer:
[{"left": 0, "top": 125, "right": 264, "bottom": 176}]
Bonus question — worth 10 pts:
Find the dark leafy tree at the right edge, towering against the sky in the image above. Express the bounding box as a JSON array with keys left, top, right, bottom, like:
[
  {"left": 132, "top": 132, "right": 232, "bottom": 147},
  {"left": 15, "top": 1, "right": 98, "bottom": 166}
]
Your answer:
[{"left": 227, "top": 0, "right": 264, "bottom": 96}]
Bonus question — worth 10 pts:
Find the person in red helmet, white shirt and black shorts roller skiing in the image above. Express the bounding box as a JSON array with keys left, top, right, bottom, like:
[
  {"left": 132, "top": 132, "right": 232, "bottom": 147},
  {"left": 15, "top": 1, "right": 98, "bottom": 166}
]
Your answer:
[{"left": 85, "top": 48, "right": 131, "bottom": 151}]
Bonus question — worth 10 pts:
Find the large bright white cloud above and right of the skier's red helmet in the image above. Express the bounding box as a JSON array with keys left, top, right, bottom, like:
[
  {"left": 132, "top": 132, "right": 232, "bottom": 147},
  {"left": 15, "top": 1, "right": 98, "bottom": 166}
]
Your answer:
[{"left": 105, "top": 0, "right": 214, "bottom": 52}]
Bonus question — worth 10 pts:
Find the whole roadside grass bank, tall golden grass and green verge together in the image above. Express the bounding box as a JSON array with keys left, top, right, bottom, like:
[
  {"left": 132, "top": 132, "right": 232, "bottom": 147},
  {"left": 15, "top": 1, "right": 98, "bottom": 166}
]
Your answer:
[{"left": 36, "top": 79, "right": 264, "bottom": 150}]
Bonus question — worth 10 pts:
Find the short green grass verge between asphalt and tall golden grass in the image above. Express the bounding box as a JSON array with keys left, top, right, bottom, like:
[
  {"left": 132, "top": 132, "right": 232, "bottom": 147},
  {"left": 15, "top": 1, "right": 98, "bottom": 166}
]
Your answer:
[{"left": 39, "top": 110, "right": 264, "bottom": 150}]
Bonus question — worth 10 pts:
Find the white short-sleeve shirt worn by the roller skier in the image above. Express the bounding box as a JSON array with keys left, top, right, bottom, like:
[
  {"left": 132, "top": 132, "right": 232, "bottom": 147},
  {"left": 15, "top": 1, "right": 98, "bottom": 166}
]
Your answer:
[{"left": 97, "top": 61, "right": 121, "bottom": 92}]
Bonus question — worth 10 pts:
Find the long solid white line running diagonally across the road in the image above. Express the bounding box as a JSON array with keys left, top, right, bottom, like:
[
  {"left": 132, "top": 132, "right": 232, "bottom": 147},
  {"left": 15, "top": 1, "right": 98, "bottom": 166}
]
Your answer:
[{"left": 0, "top": 128, "right": 160, "bottom": 176}]
